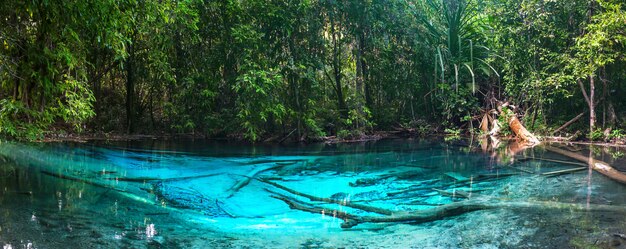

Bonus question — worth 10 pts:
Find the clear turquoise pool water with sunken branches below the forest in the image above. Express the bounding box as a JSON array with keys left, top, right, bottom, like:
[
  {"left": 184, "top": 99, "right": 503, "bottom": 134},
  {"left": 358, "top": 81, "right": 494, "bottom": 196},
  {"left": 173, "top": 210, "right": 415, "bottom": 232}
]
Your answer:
[{"left": 0, "top": 139, "right": 626, "bottom": 249}]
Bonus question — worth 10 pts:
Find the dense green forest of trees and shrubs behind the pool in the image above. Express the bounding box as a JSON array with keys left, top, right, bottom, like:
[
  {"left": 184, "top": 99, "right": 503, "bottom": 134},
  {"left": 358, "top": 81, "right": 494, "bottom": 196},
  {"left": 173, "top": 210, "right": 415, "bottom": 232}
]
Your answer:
[{"left": 0, "top": 0, "right": 626, "bottom": 141}]
